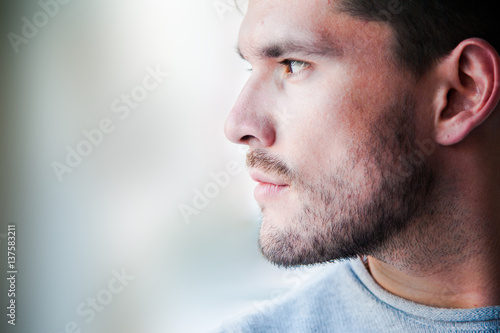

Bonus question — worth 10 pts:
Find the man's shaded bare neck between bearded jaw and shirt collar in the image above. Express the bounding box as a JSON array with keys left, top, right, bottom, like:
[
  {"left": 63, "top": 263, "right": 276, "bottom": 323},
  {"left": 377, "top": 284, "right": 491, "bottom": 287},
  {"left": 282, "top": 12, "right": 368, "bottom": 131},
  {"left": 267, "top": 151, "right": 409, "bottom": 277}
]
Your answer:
[{"left": 368, "top": 176, "right": 500, "bottom": 308}]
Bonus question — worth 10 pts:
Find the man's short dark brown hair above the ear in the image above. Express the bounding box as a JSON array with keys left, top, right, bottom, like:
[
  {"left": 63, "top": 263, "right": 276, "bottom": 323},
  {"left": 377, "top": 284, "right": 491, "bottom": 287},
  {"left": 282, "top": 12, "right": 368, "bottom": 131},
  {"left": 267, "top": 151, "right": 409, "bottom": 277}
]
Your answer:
[{"left": 335, "top": 0, "right": 500, "bottom": 77}]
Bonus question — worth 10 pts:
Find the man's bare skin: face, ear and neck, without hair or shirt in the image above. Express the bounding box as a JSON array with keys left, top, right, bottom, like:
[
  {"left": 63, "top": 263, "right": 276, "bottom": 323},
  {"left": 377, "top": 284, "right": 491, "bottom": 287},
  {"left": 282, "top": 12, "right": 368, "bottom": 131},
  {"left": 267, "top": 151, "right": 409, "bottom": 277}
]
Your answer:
[{"left": 225, "top": 0, "right": 500, "bottom": 308}]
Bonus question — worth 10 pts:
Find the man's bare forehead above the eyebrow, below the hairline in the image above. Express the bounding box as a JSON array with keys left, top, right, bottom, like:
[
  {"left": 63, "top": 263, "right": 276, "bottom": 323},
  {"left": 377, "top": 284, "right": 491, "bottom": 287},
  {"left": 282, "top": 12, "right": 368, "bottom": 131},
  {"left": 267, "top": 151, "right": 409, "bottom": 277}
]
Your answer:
[{"left": 238, "top": 0, "right": 392, "bottom": 58}]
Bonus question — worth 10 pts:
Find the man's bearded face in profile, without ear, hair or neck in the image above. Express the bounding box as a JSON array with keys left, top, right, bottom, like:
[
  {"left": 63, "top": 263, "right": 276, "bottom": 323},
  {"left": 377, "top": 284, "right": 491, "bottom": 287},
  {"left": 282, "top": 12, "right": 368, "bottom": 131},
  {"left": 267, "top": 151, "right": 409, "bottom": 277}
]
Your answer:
[{"left": 225, "top": 0, "right": 432, "bottom": 266}]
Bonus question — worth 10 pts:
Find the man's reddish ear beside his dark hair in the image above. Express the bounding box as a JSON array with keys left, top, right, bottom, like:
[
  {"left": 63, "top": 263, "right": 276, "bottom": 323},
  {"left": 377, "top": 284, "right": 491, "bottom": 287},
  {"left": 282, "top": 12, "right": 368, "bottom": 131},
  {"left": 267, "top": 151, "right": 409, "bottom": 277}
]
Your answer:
[{"left": 434, "top": 38, "right": 500, "bottom": 146}]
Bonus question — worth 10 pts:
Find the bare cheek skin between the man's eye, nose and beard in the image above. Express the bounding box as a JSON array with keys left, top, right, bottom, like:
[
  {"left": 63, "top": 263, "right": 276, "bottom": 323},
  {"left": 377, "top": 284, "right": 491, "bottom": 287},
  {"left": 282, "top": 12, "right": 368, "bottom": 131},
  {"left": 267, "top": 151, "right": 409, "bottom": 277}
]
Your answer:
[{"left": 278, "top": 54, "right": 407, "bottom": 184}]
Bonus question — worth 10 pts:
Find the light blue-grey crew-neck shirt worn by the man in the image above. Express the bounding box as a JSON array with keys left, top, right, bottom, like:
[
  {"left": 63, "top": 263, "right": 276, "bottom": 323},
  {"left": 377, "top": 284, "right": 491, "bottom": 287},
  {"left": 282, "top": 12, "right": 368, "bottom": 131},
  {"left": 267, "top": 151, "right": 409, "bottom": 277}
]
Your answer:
[{"left": 215, "top": 259, "right": 500, "bottom": 333}]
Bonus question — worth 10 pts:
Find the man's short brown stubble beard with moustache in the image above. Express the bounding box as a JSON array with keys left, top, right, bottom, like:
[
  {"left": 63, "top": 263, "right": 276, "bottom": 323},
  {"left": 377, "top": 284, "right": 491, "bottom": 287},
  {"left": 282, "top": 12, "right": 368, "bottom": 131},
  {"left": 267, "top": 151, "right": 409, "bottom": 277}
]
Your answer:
[{"left": 247, "top": 96, "right": 433, "bottom": 267}]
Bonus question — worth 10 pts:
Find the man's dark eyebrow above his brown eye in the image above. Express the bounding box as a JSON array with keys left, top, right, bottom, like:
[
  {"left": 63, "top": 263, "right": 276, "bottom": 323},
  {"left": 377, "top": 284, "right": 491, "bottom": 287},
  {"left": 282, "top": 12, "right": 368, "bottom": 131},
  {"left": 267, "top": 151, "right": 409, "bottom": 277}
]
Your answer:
[{"left": 236, "top": 38, "right": 342, "bottom": 60}]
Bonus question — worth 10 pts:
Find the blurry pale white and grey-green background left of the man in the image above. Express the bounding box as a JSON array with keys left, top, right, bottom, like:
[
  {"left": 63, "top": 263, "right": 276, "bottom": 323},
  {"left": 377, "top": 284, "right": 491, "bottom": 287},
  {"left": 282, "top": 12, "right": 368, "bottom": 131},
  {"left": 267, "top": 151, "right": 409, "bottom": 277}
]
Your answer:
[{"left": 0, "top": 0, "right": 318, "bottom": 333}]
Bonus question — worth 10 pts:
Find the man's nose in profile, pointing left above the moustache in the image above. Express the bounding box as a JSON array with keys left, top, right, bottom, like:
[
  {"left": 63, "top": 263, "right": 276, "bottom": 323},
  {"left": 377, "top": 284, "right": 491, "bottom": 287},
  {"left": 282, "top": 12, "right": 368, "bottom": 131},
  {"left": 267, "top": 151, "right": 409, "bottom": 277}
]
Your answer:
[{"left": 224, "top": 78, "right": 276, "bottom": 148}]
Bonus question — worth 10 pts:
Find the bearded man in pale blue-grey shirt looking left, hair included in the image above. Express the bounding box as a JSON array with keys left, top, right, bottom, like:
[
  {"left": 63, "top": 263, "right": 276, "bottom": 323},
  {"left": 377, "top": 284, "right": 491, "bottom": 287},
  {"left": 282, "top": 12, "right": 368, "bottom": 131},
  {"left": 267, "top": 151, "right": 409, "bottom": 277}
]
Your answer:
[{"left": 221, "top": 0, "right": 500, "bottom": 332}]
